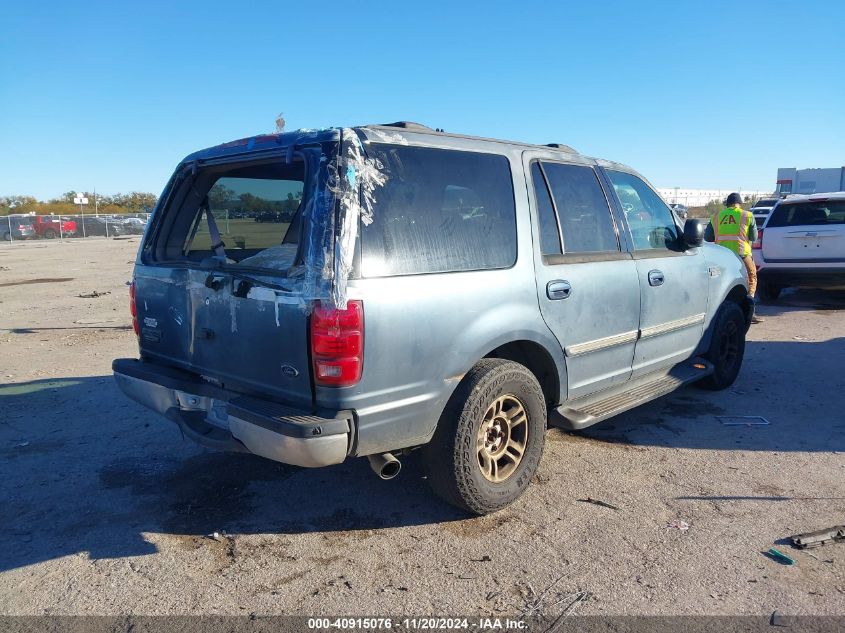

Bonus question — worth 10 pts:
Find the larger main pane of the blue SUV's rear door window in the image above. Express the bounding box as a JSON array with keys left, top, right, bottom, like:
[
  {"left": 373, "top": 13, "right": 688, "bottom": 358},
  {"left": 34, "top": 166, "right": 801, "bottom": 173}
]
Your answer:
[{"left": 543, "top": 163, "right": 619, "bottom": 253}]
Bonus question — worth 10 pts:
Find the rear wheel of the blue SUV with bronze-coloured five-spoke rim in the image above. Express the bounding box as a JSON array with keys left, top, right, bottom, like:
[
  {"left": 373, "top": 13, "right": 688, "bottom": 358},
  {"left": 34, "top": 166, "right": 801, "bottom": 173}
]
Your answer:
[{"left": 422, "top": 358, "right": 546, "bottom": 515}]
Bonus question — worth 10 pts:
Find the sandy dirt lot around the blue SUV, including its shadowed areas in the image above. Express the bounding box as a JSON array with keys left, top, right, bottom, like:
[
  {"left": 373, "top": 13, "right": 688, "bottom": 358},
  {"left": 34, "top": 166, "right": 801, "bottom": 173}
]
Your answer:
[{"left": 0, "top": 238, "right": 845, "bottom": 615}]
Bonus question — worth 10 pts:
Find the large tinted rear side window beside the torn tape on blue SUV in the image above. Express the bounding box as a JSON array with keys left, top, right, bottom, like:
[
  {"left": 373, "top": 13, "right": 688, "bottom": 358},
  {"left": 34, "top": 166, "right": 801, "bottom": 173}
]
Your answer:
[{"left": 361, "top": 144, "right": 516, "bottom": 277}]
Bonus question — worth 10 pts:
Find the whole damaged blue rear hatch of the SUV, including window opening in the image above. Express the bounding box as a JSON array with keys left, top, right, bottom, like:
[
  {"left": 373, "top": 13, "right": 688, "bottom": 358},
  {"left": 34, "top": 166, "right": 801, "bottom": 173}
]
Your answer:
[{"left": 135, "top": 133, "right": 337, "bottom": 405}]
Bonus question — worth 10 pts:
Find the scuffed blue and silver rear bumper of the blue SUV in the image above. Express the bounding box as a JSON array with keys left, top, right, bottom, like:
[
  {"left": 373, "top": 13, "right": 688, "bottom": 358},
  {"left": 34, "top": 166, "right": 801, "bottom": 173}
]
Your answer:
[{"left": 112, "top": 358, "right": 353, "bottom": 468}]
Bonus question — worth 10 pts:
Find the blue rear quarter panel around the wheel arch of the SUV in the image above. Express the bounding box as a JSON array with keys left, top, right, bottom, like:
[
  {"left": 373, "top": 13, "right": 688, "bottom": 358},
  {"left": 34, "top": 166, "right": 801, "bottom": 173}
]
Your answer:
[{"left": 316, "top": 148, "right": 566, "bottom": 455}]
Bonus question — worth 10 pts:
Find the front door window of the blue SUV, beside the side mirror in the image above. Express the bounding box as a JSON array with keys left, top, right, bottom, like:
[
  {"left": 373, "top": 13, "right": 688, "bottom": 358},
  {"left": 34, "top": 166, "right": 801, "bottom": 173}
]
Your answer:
[{"left": 607, "top": 170, "right": 679, "bottom": 251}]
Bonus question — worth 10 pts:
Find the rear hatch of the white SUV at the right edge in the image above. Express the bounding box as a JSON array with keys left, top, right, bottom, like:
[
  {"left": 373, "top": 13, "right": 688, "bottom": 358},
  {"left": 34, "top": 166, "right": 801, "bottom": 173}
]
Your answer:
[{"left": 762, "top": 198, "right": 845, "bottom": 263}]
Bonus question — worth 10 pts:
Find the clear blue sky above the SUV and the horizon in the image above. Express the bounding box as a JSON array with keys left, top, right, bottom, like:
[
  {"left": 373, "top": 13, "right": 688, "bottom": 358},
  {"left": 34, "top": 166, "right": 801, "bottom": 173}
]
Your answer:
[{"left": 0, "top": 0, "right": 845, "bottom": 199}]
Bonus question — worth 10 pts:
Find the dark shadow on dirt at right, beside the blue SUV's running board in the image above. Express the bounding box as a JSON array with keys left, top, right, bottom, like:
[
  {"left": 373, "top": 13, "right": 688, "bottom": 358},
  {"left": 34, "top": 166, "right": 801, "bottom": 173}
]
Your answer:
[{"left": 580, "top": 338, "right": 845, "bottom": 452}]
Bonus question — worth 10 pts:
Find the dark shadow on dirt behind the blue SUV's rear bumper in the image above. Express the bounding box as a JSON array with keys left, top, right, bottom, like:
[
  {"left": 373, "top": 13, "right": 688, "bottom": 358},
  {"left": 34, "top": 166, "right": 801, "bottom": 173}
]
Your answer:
[{"left": 0, "top": 376, "right": 467, "bottom": 570}]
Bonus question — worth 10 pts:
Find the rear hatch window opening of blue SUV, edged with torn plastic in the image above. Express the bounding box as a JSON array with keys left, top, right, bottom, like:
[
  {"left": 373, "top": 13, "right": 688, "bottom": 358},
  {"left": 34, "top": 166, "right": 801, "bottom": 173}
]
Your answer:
[{"left": 148, "top": 151, "right": 324, "bottom": 272}]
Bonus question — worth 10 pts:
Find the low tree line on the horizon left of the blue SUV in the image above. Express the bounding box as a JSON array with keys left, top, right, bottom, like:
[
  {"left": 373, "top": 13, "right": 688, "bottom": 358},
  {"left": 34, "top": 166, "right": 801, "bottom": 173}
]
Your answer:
[{"left": 0, "top": 191, "right": 158, "bottom": 215}]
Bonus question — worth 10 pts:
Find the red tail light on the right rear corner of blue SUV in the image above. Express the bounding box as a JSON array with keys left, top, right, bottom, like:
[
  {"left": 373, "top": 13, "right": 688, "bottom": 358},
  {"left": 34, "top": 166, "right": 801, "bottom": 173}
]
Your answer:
[{"left": 311, "top": 301, "right": 364, "bottom": 387}]
